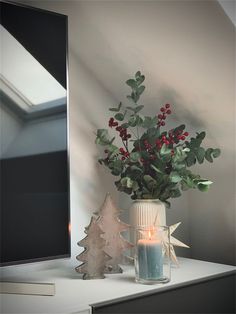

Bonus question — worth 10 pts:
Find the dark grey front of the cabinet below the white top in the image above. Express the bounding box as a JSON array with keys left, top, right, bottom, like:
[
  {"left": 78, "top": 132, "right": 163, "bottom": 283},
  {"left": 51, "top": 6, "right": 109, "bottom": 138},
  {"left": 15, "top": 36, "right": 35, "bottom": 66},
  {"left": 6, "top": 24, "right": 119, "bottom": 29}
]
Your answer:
[{"left": 92, "top": 275, "right": 236, "bottom": 314}]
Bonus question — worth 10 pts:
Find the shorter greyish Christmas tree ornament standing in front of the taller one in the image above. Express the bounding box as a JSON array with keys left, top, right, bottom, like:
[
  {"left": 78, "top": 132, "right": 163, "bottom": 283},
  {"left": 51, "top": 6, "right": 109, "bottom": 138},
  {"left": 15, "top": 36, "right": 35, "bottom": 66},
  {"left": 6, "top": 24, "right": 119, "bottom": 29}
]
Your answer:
[{"left": 75, "top": 217, "right": 110, "bottom": 279}]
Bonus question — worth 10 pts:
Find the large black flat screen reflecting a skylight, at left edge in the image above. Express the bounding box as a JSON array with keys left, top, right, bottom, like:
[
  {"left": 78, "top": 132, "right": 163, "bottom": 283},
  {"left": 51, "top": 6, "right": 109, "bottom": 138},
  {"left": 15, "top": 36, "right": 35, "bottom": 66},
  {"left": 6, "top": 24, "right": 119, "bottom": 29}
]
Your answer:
[{"left": 0, "top": 2, "right": 70, "bottom": 265}]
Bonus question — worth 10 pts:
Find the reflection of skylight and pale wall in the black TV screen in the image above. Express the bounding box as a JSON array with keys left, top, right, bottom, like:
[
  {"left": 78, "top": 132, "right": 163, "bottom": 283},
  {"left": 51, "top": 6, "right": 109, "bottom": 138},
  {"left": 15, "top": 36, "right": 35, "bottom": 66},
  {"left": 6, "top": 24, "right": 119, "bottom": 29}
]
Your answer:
[{"left": 0, "top": 25, "right": 66, "bottom": 158}]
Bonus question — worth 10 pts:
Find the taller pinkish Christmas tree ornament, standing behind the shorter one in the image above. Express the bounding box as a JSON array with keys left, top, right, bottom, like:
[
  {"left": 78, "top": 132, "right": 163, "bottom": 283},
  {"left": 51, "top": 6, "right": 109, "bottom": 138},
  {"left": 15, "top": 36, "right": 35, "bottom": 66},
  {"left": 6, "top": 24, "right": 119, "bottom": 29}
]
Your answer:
[{"left": 96, "top": 193, "right": 133, "bottom": 273}]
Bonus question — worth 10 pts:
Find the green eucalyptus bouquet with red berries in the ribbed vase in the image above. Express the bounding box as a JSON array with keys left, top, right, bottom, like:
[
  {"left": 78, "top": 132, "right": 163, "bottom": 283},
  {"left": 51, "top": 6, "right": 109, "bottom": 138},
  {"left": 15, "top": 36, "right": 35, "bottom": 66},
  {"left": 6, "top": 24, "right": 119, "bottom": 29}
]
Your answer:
[{"left": 96, "top": 71, "right": 220, "bottom": 203}]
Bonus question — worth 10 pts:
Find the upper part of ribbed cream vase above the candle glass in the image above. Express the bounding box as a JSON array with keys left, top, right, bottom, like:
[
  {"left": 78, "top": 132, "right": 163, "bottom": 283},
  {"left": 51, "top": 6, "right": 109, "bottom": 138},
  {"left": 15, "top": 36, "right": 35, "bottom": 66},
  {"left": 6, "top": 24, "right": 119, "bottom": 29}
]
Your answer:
[{"left": 129, "top": 199, "right": 166, "bottom": 228}]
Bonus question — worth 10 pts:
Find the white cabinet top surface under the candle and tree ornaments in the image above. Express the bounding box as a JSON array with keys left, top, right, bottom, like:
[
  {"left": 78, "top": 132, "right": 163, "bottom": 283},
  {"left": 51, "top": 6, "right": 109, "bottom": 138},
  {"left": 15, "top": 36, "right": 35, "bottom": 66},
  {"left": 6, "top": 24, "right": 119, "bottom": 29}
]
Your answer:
[{"left": 0, "top": 258, "right": 236, "bottom": 314}]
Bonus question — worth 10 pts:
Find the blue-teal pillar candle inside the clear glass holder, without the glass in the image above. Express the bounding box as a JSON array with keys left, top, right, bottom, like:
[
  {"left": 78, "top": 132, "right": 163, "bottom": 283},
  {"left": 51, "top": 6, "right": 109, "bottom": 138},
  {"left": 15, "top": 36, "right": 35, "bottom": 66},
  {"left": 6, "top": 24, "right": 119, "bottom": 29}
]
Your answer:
[{"left": 137, "top": 239, "right": 163, "bottom": 280}]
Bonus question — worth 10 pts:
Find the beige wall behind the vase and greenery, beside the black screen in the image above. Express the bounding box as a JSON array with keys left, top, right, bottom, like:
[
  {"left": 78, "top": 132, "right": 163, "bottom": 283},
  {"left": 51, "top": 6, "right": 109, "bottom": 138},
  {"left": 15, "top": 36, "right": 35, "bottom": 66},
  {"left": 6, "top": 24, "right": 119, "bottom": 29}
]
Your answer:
[{"left": 15, "top": 0, "right": 236, "bottom": 263}]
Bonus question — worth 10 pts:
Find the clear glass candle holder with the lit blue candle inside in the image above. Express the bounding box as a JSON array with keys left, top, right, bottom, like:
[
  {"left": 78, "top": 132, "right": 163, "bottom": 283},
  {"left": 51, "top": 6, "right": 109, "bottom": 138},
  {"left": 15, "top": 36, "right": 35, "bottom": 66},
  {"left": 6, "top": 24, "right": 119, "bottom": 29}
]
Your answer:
[{"left": 134, "top": 226, "right": 171, "bottom": 284}]
